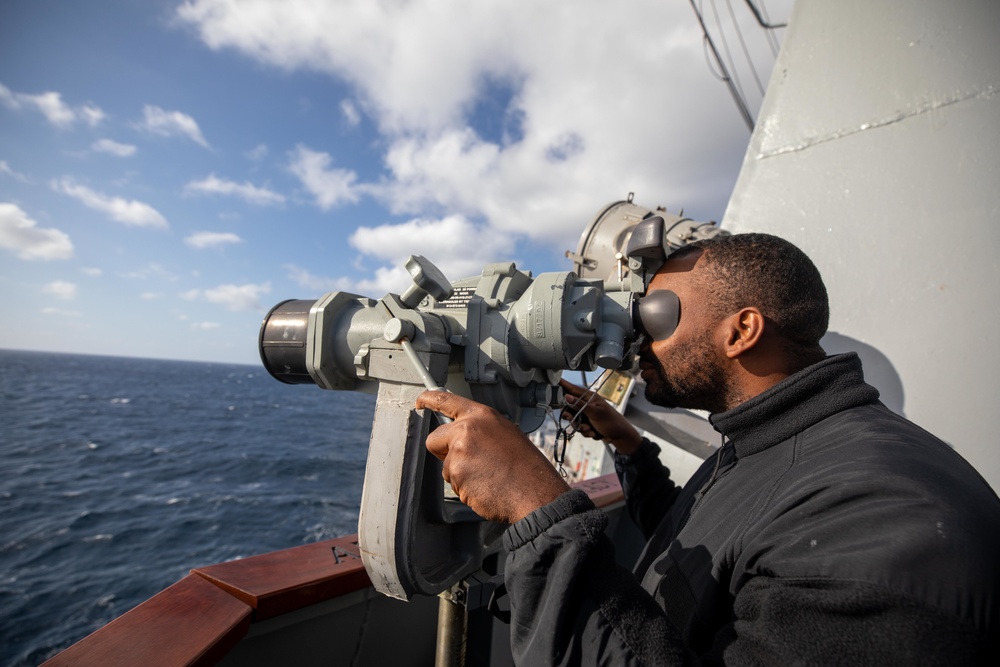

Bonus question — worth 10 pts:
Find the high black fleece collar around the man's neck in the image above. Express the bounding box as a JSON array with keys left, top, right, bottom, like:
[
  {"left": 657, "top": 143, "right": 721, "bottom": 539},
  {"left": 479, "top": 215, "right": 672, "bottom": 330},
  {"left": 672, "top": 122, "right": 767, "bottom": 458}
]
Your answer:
[{"left": 708, "top": 352, "right": 878, "bottom": 457}]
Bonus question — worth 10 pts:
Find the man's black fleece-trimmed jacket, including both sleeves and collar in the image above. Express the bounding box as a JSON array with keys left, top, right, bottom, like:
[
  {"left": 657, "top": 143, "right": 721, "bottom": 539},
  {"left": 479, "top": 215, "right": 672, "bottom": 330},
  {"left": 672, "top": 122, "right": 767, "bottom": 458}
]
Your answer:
[{"left": 504, "top": 354, "right": 1000, "bottom": 665}]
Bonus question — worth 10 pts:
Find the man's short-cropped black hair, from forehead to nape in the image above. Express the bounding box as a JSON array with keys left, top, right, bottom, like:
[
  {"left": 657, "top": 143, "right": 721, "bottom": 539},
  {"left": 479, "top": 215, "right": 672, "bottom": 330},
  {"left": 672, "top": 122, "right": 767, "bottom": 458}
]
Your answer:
[{"left": 681, "top": 234, "right": 830, "bottom": 363}]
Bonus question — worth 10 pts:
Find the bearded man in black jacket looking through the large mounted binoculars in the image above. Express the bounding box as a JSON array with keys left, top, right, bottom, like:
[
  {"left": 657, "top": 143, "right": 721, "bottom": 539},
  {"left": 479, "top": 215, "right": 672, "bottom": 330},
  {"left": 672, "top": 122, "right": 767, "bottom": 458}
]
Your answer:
[{"left": 417, "top": 234, "right": 1000, "bottom": 665}]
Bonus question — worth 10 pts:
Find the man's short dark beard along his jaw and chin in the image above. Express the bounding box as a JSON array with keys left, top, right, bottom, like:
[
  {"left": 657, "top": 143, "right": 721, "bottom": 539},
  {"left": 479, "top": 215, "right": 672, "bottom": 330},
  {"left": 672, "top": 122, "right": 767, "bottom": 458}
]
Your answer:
[{"left": 641, "top": 338, "right": 730, "bottom": 412}]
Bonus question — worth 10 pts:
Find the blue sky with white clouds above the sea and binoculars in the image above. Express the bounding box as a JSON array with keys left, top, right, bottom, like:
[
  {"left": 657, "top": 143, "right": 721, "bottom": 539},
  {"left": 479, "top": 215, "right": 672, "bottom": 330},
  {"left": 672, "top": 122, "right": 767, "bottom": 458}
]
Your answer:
[{"left": 0, "top": 0, "right": 791, "bottom": 364}]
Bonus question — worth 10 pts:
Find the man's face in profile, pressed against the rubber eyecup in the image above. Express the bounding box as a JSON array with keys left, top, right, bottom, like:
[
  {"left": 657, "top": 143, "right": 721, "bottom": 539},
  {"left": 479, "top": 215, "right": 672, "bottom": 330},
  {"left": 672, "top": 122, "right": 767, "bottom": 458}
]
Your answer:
[{"left": 639, "top": 252, "right": 728, "bottom": 412}]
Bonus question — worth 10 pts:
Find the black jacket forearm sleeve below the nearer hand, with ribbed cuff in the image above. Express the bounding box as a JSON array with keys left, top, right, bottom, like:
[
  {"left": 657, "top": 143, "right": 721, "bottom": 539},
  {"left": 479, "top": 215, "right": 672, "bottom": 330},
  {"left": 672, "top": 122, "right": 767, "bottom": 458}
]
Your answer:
[{"left": 504, "top": 490, "right": 687, "bottom": 665}]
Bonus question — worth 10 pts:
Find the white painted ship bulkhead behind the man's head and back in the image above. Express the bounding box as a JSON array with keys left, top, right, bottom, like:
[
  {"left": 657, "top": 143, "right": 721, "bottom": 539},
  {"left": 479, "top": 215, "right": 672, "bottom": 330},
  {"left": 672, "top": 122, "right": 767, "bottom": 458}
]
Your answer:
[{"left": 723, "top": 0, "right": 1000, "bottom": 489}]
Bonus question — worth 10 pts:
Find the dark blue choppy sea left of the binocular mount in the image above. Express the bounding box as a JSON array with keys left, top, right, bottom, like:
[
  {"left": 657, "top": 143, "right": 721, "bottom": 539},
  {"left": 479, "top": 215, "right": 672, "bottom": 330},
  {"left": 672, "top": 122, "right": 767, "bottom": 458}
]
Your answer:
[{"left": 0, "top": 350, "right": 374, "bottom": 665}]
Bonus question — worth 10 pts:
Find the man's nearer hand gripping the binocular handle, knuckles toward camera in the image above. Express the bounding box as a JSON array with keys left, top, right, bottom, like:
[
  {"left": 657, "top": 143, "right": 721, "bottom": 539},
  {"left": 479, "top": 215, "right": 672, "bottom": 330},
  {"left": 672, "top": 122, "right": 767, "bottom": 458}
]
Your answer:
[{"left": 416, "top": 391, "right": 569, "bottom": 523}]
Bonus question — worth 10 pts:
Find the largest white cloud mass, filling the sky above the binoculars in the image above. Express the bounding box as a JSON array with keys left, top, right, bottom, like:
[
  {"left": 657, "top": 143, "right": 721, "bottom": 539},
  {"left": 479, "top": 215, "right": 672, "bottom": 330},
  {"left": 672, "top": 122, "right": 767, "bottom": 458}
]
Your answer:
[{"left": 177, "top": 0, "right": 791, "bottom": 249}]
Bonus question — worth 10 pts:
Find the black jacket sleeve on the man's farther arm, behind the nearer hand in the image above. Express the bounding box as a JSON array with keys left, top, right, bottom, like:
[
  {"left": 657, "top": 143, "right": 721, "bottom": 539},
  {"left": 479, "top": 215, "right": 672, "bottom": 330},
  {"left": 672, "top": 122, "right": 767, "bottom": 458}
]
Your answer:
[{"left": 615, "top": 438, "right": 681, "bottom": 540}]
